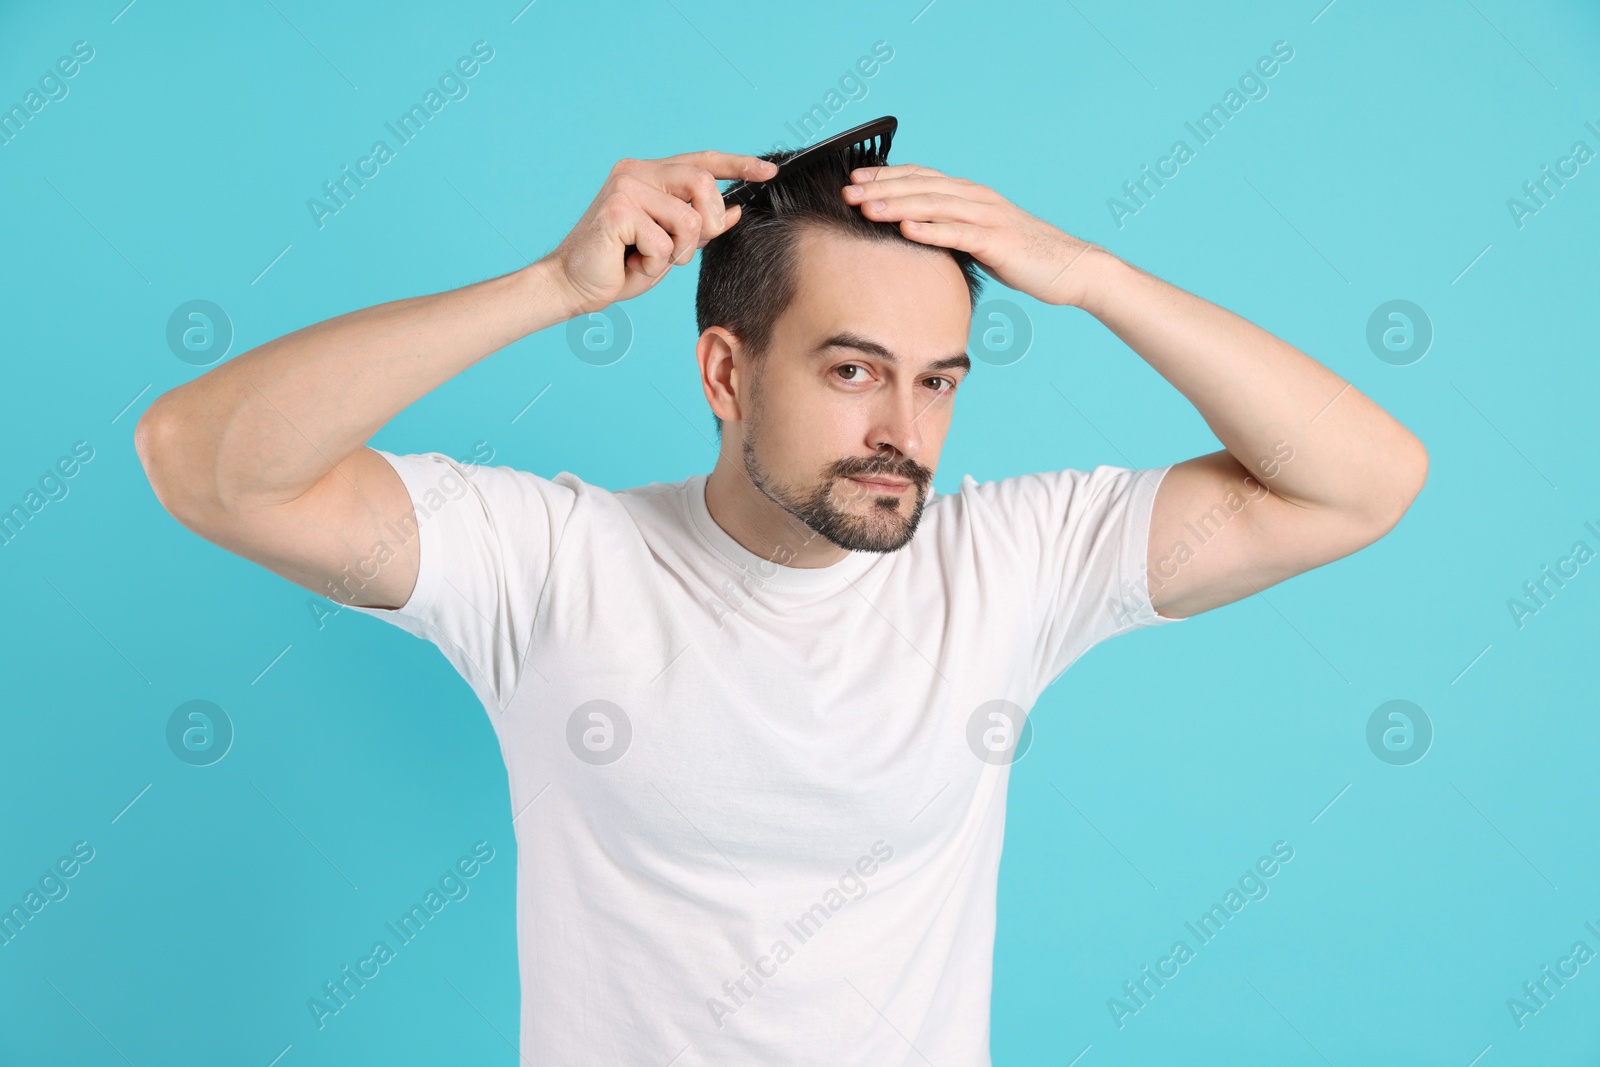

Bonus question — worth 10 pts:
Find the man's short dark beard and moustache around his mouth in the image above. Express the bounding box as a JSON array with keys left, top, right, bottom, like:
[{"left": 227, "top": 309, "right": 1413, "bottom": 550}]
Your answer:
[{"left": 742, "top": 411, "right": 933, "bottom": 552}]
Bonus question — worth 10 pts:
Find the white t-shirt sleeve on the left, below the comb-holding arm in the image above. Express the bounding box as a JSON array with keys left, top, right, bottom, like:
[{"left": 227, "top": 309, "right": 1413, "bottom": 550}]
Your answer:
[{"left": 346, "top": 450, "right": 582, "bottom": 710}]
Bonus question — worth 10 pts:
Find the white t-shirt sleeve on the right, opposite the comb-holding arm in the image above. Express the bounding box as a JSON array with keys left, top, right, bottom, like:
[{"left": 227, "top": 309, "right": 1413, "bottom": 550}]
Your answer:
[{"left": 953, "top": 466, "right": 1182, "bottom": 691}]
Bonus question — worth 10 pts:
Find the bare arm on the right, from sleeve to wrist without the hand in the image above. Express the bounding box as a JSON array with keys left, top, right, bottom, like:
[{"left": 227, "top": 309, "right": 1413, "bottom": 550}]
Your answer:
[{"left": 1074, "top": 246, "right": 1427, "bottom": 617}]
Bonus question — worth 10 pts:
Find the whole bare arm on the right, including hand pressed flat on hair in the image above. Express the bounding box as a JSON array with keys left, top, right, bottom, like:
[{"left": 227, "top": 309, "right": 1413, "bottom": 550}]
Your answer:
[{"left": 843, "top": 165, "right": 1427, "bottom": 617}]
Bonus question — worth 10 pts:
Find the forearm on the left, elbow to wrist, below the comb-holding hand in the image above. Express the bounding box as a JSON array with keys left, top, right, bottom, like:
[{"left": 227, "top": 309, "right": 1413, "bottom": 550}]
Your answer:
[{"left": 139, "top": 261, "right": 568, "bottom": 509}]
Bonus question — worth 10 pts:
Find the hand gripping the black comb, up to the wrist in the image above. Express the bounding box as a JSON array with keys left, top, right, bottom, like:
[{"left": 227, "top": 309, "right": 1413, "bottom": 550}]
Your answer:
[{"left": 539, "top": 152, "right": 778, "bottom": 315}]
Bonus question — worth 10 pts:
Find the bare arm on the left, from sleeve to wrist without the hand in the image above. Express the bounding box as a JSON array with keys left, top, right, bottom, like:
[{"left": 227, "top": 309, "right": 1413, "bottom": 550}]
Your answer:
[{"left": 134, "top": 259, "right": 573, "bottom": 608}]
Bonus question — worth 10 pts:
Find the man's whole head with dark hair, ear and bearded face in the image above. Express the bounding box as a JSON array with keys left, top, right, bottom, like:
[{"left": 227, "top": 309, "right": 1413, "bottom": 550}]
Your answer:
[{"left": 694, "top": 152, "right": 982, "bottom": 552}]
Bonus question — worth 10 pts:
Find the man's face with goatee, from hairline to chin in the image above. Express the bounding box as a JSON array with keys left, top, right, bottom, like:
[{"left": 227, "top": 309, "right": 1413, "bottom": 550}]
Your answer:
[{"left": 731, "top": 227, "right": 971, "bottom": 552}]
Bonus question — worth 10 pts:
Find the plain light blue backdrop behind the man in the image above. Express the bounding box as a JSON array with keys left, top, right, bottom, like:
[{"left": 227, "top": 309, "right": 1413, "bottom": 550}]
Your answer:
[{"left": 0, "top": 0, "right": 1600, "bottom": 1067}]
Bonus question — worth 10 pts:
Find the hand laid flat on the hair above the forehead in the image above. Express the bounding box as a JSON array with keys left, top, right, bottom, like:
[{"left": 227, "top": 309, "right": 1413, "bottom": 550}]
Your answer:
[{"left": 843, "top": 163, "right": 1109, "bottom": 307}]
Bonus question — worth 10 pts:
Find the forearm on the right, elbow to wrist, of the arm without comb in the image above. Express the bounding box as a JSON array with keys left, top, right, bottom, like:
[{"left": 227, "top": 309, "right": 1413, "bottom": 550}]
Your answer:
[{"left": 1078, "top": 251, "right": 1424, "bottom": 522}]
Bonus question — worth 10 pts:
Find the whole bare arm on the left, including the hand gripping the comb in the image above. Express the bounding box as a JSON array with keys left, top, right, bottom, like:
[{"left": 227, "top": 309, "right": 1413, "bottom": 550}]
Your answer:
[{"left": 133, "top": 150, "right": 778, "bottom": 608}]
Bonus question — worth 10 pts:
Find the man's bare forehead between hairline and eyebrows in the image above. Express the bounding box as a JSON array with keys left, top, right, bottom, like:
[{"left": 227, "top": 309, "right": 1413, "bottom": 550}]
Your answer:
[{"left": 784, "top": 226, "right": 971, "bottom": 342}]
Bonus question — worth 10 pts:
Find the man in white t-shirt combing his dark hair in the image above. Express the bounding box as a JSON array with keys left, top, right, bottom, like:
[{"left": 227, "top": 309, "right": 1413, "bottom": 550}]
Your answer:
[{"left": 136, "top": 152, "right": 1427, "bottom": 1067}]
